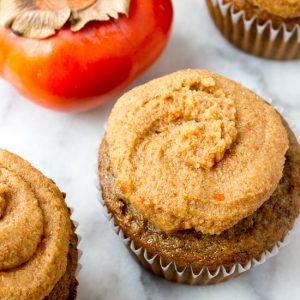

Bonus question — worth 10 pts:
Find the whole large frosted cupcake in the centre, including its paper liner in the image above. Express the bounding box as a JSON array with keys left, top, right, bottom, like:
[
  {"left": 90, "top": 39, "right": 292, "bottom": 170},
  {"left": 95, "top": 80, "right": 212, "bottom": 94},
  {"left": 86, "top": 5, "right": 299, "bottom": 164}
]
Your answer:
[{"left": 99, "top": 70, "right": 300, "bottom": 284}]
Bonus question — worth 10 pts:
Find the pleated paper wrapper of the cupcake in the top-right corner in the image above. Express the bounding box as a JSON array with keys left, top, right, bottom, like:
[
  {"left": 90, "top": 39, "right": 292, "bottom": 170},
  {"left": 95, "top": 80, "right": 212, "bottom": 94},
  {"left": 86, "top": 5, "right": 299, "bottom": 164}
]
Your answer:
[{"left": 206, "top": 0, "right": 300, "bottom": 60}]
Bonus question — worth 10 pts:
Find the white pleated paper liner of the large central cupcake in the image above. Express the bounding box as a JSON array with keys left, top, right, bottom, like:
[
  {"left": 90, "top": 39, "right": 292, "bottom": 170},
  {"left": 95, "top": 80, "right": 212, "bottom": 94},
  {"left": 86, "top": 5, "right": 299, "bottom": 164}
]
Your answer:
[{"left": 95, "top": 85, "right": 300, "bottom": 285}]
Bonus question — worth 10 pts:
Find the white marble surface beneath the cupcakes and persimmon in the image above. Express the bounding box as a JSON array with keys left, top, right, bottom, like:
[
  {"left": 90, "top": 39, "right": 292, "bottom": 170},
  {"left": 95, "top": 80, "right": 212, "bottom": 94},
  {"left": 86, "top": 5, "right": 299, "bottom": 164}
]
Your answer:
[{"left": 0, "top": 0, "right": 300, "bottom": 300}]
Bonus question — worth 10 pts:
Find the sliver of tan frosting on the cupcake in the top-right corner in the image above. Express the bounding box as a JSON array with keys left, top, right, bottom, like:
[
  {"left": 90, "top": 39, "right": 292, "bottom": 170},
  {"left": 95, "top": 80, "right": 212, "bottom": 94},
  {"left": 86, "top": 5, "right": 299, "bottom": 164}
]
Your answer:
[{"left": 247, "top": 0, "right": 300, "bottom": 18}]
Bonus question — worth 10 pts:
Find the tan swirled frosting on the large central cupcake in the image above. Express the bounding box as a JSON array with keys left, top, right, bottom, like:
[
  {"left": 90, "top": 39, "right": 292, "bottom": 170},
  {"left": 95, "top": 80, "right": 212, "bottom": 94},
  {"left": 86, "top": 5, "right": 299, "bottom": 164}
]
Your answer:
[{"left": 106, "top": 70, "right": 288, "bottom": 234}]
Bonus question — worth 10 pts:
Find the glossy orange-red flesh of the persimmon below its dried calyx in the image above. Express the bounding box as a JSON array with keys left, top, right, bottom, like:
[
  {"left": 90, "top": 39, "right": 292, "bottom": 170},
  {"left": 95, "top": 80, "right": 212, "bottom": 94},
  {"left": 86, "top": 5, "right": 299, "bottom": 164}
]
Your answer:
[{"left": 0, "top": 0, "right": 173, "bottom": 112}]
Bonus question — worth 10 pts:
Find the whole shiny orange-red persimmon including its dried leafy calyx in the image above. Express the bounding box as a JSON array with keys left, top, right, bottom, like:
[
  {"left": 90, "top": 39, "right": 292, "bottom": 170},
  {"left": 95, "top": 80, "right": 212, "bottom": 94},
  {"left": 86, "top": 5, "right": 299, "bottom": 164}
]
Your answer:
[{"left": 0, "top": 0, "right": 173, "bottom": 112}]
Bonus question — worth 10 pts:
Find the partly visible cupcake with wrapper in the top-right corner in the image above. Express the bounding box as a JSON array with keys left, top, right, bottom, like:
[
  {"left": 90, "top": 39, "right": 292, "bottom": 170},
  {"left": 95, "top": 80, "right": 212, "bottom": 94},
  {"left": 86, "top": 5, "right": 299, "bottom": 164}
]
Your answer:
[{"left": 206, "top": 0, "right": 300, "bottom": 60}]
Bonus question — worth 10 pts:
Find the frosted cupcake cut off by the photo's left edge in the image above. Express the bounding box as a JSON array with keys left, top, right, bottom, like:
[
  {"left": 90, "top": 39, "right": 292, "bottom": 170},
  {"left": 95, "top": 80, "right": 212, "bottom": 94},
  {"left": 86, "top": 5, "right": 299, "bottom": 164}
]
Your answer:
[{"left": 0, "top": 150, "right": 78, "bottom": 300}]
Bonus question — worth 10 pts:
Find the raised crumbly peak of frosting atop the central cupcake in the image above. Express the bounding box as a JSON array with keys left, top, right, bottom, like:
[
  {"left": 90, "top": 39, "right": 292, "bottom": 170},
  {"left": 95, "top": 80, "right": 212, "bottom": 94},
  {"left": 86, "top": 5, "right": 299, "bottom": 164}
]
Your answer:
[{"left": 164, "top": 88, "right": 237, "bottom": 169}]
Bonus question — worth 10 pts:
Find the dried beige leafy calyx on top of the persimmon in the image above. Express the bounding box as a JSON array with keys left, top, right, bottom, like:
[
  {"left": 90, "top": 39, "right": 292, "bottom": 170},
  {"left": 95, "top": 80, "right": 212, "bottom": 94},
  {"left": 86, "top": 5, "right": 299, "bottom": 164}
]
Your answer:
[{"left": 0, "top": 0, "right": 130, "bottom": 39}]
